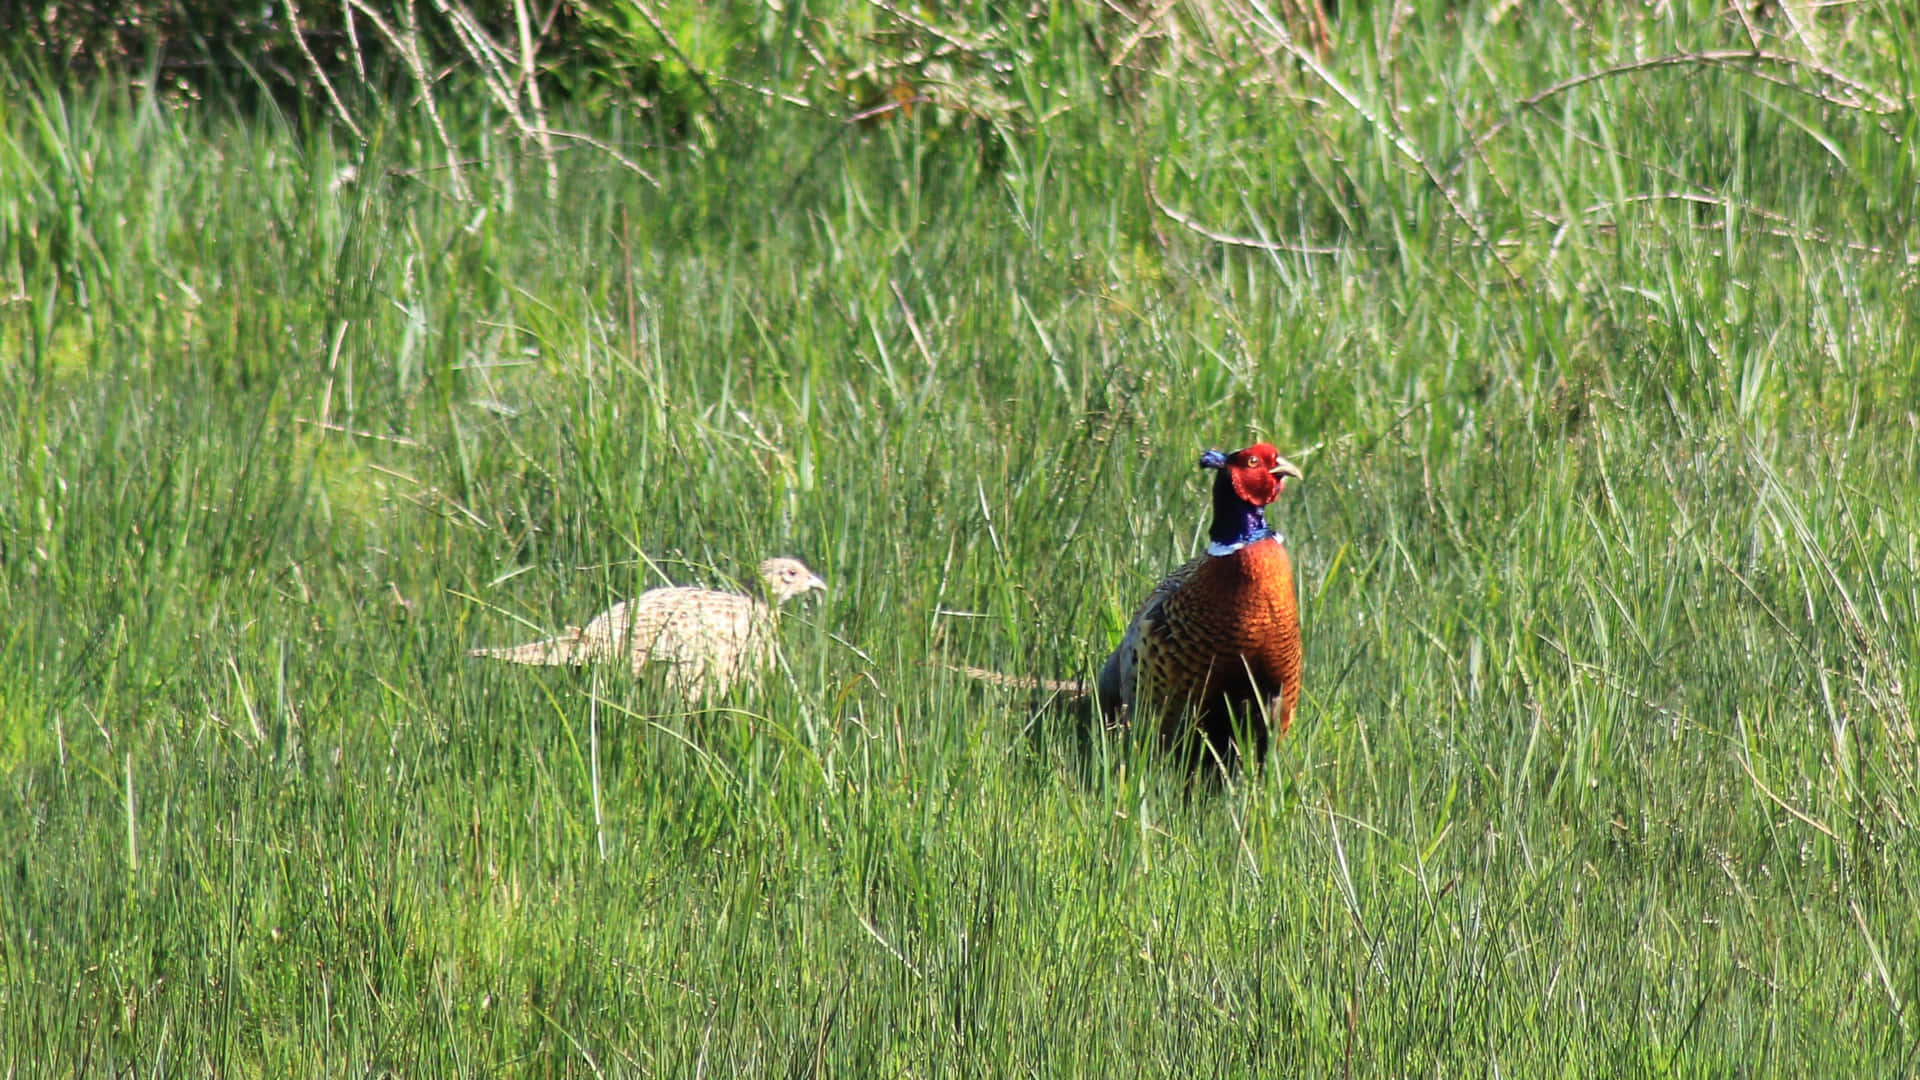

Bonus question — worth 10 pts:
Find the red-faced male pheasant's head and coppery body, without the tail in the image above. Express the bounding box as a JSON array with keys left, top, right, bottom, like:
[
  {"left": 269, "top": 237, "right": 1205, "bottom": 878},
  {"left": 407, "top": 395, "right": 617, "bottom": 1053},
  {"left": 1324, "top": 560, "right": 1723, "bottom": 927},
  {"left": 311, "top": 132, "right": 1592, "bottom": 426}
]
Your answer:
[{"left": 1096, "top": 442, "right": 1300, "bottom": 769}]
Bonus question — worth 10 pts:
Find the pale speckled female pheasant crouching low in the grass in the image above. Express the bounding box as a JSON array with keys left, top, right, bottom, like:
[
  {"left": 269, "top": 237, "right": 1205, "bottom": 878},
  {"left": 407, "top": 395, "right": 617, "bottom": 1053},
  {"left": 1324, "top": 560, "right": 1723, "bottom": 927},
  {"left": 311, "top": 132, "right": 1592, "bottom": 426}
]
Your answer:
[{"left": 467, "top": 559, "right": 828, "bottom": 701}]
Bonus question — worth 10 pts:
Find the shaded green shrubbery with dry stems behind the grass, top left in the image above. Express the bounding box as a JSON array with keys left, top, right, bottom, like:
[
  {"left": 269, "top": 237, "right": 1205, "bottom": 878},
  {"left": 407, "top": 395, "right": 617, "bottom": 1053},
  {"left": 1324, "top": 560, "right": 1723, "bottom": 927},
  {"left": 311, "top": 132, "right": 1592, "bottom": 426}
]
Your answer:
[{"left": 0, "top": 0, "right": 1048, "bottom": 135}]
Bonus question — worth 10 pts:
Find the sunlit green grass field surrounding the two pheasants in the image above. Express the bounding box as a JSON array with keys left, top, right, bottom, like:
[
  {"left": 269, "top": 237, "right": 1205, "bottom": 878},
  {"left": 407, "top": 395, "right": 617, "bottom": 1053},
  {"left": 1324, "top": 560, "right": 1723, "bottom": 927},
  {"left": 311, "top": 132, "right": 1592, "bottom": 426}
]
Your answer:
[{"left": 0, "top": 0, "right": 1920, "bottom": 1076}]
